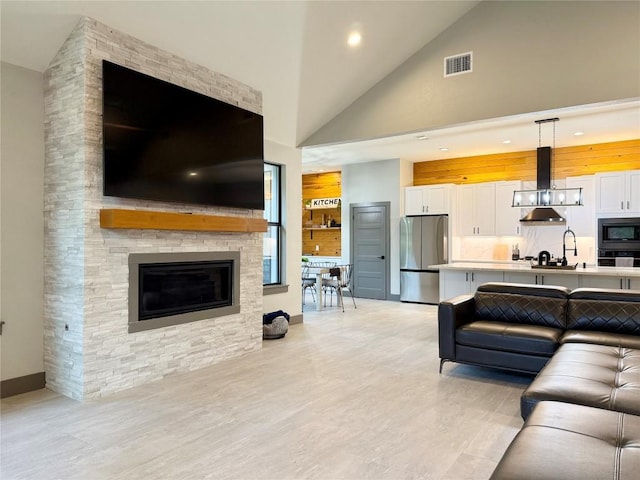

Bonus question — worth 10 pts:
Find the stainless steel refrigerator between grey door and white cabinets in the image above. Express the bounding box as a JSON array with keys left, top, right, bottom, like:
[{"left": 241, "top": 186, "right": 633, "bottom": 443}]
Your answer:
[{"left": 400, "top": 215, "right": 449, "bottom": 304}]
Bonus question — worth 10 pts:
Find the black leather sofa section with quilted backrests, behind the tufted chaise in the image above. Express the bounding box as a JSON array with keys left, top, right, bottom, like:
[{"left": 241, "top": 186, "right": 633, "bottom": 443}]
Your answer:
[{"left": 438, "top": 283, "right": 640, "bottom": 374}]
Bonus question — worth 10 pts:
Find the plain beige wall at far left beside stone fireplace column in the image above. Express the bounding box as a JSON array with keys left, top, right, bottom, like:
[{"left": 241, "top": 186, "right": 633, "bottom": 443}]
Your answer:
[{"left": 0, "top": 63, "right": 44, "bottom": 380}]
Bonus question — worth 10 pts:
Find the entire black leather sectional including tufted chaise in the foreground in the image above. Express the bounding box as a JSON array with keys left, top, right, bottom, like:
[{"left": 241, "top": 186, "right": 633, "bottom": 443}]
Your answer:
[{"left": 438, "top": 283, "right": 640, "bottom": 480}]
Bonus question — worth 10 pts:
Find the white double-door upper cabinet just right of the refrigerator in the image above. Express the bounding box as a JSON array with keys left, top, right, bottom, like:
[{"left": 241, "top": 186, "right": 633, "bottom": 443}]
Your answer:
[{"left": 457, "top": 183, "right": 496, "bottom": 236}]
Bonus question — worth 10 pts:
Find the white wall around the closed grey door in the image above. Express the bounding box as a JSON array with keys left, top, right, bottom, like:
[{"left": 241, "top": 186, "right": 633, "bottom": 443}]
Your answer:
[{"left": 342, "top": 159, "right": 407, "bottom": 295}]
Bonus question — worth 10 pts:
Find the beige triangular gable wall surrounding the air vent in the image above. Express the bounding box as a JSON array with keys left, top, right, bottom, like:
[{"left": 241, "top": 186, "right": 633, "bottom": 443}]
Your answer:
[{"left": 303, "top": 1, "right": 640, "bottom": 145}]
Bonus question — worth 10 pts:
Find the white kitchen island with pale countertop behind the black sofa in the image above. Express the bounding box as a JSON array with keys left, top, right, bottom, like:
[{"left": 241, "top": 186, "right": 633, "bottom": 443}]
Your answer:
[{"left": 429, "top": 261, "right": 640, "bottom": 300}]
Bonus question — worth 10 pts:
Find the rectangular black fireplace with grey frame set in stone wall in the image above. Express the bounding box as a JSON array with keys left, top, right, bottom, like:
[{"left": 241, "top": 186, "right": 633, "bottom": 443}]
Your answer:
[{"left": 129, "top": 252, "right": 240, "bottom": 333}]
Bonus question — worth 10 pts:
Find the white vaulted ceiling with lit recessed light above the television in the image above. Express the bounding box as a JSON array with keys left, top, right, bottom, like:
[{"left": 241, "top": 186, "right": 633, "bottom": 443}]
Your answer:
[{"left": 0, "top": 0, "right": 478, "bottom": 145}]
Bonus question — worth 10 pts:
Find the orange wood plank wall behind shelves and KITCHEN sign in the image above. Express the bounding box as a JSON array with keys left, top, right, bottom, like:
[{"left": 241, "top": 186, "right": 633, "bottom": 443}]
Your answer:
[{"left": 302, "top": 172, "right": 342, "bottom": 257}]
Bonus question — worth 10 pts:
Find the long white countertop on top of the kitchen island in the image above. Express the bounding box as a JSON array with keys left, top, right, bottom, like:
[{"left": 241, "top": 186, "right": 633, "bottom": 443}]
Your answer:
[{"left": 429, "top": 261, "right": 640, "bottom": 277}]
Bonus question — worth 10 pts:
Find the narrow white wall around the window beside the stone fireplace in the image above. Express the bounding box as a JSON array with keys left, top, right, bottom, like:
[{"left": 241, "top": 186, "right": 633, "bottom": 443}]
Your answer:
[{"left": 263, "top": 139, "right": 302, "bottom": 315}]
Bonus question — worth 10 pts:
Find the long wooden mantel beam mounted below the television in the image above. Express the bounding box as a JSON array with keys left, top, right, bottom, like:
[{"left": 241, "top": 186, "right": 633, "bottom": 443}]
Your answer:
[{"left": 100, "top": 208, "right": 267, "bottom": 233}]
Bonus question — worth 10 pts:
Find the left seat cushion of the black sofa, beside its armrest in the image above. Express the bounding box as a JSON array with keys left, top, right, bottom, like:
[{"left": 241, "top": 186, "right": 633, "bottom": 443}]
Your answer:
[{"left": 456, "top": 320, "right": 563, "bottom": 356}]
